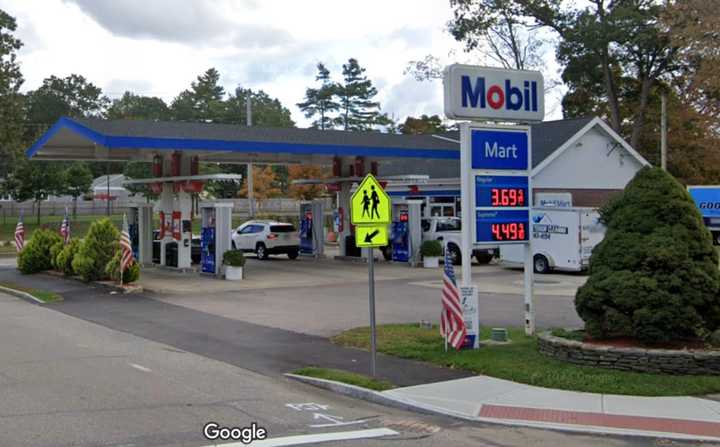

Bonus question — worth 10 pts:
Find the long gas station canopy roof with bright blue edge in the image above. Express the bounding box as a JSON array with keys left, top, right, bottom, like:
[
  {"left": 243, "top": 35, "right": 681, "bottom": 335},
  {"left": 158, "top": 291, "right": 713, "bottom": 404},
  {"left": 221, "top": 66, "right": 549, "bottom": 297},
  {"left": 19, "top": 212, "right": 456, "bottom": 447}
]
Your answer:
[{"left": 26, "top": 117, "right": 459, "bottom": 164}]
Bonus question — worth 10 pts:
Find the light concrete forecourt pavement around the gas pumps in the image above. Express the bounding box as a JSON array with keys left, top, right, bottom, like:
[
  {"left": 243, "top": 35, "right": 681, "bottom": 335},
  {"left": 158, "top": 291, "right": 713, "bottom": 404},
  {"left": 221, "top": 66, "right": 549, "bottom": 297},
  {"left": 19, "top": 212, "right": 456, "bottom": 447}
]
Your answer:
[{"left": 146, "top": 258, "right": 585, "bottom": 337}]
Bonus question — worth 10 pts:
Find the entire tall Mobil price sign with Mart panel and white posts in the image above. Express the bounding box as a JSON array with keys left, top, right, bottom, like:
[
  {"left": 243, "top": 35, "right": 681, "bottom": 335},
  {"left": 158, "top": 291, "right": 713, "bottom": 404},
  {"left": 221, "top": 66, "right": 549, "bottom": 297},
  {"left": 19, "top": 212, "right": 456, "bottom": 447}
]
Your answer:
[{"left": 443, "top": 64, "right": 545, "bottom": 334}]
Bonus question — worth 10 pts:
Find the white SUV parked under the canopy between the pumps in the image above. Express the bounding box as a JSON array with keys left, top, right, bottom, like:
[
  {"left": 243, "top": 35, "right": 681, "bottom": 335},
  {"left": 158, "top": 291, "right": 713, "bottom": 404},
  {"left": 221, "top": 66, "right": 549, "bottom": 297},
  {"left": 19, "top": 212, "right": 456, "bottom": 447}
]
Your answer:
[{"left": 232, "top": 220, "right": 300, "bottom": 259}]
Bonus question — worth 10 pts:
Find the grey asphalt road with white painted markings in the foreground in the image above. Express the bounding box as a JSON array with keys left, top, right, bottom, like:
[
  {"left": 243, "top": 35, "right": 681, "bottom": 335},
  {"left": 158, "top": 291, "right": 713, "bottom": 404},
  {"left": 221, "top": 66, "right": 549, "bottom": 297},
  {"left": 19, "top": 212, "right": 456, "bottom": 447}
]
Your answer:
[{"left": 0, "top": 294, "right": 692, "bottom": 447}]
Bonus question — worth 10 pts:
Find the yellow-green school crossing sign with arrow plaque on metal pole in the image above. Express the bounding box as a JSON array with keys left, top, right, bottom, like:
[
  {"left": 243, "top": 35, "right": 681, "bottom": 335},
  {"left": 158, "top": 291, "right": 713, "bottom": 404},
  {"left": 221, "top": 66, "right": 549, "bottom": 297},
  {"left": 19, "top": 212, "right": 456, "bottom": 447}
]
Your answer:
[{"left": 350, "top": 174, "right": 391, "bottom": 377}]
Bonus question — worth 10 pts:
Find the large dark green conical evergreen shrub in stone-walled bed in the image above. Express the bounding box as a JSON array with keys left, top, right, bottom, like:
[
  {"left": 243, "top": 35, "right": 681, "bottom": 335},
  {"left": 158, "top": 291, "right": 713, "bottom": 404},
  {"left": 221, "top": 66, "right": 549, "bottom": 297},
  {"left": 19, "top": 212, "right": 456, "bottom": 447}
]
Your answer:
[{"left": 575, "top": 168, "right": 720, "bottom": 343}]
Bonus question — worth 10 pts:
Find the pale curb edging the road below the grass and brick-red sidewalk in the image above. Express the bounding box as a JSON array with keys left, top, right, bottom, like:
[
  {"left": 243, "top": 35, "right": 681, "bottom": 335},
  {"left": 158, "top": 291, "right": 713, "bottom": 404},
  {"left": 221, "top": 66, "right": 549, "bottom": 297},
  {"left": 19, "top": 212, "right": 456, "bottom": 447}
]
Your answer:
[{"left": 284, "top": 373, "right": 719, "bottom": 442}]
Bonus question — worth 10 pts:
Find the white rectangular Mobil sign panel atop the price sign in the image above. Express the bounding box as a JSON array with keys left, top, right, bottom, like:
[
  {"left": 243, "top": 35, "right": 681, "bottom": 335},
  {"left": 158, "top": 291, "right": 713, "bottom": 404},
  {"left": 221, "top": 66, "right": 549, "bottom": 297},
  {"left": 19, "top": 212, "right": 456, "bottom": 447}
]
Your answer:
[{"left": 443, "top": 64, "right": 545, "bottom": 122}]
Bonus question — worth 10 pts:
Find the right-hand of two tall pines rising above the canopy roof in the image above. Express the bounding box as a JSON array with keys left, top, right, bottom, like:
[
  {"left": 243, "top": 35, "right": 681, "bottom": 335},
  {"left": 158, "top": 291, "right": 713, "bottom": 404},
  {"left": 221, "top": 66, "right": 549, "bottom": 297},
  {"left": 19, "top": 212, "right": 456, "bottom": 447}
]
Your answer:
[{"left": 335, "top": 58, "right": 383, "bottom": 131}]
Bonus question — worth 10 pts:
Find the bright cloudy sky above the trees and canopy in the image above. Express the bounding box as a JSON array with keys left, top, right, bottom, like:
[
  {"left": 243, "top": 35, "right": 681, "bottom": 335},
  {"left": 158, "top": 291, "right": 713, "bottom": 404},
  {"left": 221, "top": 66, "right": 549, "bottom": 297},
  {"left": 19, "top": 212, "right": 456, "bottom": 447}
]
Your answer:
[{"left": 0, "top": 0, "right": 560, "bottom": 126}]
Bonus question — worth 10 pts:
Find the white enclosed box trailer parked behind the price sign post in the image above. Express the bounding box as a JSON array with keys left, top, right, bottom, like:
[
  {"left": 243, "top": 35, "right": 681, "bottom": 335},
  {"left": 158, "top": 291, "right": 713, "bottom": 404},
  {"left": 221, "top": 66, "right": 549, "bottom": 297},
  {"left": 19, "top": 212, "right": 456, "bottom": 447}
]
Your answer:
[{"left": 500, "top": 208, "right": 605, "bottom": 273}]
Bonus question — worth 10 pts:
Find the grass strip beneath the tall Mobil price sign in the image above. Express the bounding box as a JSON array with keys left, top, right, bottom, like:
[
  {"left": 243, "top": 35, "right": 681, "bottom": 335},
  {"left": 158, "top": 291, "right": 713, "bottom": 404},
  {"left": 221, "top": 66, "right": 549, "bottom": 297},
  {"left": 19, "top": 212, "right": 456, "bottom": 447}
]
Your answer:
[{"left": 332, "top": 324, "right": 720, "bottom": 396}]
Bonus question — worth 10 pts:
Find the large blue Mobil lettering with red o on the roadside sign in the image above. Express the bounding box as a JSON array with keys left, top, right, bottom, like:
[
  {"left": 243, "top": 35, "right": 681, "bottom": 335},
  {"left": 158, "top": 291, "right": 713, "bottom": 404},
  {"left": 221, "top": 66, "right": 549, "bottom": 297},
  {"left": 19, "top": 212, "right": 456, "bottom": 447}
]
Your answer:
[{"left": 460, "top": 76, "right": 538, "bottom": 112}]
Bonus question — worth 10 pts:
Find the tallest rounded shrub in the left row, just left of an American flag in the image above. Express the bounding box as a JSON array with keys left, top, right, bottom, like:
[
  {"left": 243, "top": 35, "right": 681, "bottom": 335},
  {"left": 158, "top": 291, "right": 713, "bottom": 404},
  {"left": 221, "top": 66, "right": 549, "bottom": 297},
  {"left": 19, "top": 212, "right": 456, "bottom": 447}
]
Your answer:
[{"left": 72, "top": 218, "right": 120, "bottom": 281}]
